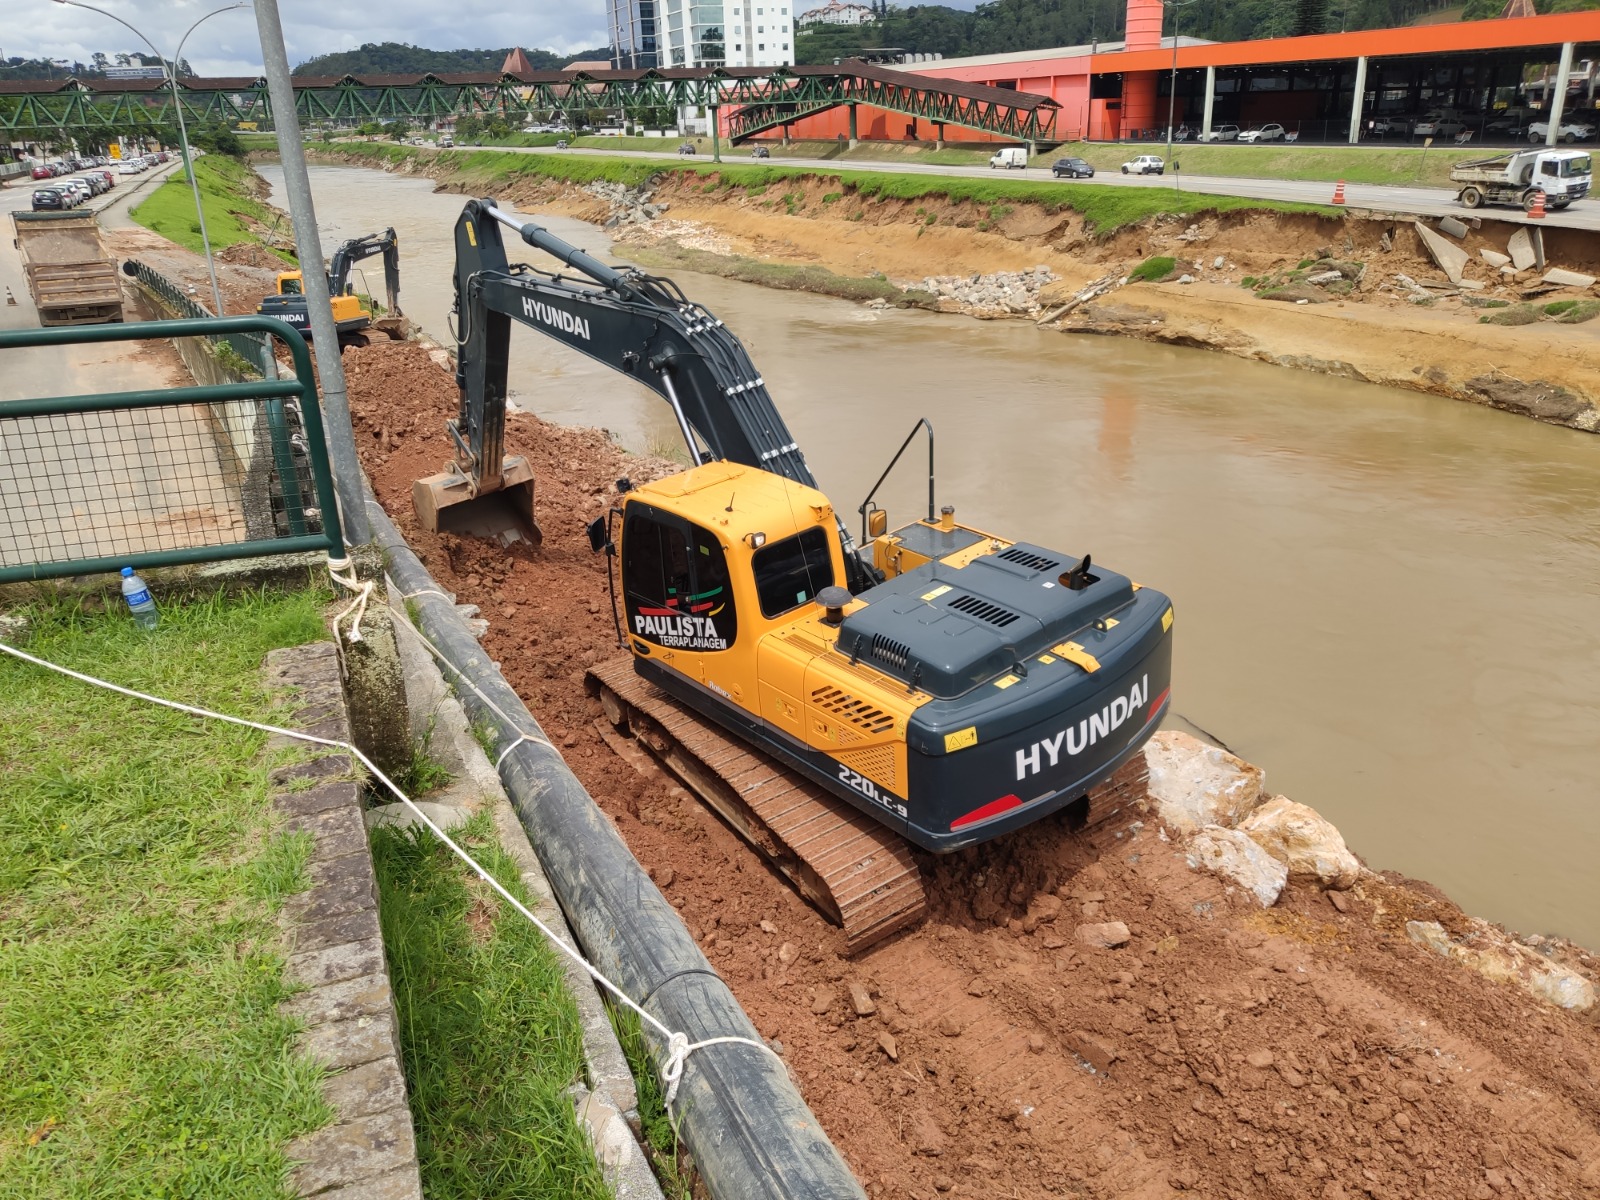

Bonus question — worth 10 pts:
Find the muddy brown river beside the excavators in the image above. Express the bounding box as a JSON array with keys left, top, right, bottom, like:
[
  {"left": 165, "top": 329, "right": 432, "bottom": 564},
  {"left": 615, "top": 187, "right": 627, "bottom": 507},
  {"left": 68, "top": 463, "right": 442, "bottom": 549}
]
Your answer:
[{"left": 261, "top": 165, "right": 1600, "bottom": 947}]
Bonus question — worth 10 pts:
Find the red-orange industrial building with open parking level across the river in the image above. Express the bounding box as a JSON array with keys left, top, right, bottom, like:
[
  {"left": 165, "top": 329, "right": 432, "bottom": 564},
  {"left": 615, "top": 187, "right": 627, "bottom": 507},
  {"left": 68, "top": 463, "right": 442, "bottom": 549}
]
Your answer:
[{"left": 758, "top": 0, "right": 1600, "bottom": 142}]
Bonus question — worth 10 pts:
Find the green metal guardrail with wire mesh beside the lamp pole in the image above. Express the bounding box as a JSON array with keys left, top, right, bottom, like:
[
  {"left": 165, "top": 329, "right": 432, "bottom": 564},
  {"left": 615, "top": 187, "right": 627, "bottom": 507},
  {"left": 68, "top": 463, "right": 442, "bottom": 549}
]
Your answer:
[{"left": 0, "top": 317, "right": 344, "bottom": 584}]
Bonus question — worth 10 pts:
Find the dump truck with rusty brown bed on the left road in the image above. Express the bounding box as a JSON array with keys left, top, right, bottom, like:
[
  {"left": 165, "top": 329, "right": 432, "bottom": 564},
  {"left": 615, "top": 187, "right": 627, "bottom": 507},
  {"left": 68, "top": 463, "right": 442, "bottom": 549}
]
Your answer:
[{"left": 11, "top": 211, "right": 122, "bottom": 326}]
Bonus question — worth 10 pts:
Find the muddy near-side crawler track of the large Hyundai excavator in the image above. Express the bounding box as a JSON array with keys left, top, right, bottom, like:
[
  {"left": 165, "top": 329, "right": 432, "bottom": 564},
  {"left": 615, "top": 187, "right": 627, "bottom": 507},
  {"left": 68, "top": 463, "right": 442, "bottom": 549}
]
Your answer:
[{"left": 589, "top": 658, "right": 926, "bottom": 954}]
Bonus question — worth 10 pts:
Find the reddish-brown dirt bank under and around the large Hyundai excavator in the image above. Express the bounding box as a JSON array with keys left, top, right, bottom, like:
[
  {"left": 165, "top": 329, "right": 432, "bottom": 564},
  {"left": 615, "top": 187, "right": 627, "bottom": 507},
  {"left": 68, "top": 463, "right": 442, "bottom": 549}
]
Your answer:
[{"left": 344, "top": 342, "right": 1600, "bottom": 1200}]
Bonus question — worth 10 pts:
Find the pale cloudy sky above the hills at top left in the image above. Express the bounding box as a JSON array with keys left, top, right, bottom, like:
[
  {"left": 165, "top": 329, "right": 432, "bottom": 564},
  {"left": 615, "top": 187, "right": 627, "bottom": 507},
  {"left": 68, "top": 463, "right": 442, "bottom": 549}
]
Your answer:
[{"left": 9, "top": 0, "right": 978, "bottom": 75}]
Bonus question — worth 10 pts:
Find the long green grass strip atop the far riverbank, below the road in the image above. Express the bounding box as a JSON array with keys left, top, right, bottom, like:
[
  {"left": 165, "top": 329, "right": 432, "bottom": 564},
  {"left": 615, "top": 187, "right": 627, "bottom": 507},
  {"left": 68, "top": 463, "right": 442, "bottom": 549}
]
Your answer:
[{"left": 321, "top": 142, "right": 1339, "bottom": 235}]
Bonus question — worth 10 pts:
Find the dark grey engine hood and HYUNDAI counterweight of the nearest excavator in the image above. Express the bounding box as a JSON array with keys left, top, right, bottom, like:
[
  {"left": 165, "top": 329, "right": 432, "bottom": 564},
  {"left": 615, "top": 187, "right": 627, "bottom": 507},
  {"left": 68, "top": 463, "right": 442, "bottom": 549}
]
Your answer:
[{"left": 834, "top": 542, "right": 1173, "bottom": 853}]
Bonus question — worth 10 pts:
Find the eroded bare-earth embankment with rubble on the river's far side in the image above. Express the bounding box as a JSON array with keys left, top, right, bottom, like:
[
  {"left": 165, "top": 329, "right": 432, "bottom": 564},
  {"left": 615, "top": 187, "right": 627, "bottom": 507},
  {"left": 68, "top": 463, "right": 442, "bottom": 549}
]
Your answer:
[{"left": 302, "top": 150, "right": 1600, "bottom": 430}]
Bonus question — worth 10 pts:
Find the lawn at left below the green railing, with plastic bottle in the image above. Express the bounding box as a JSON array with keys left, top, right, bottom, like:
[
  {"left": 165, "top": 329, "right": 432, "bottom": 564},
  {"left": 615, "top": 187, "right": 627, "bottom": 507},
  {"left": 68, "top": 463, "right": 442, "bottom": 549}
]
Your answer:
[{"left": 0, "top": 592, "right": 333, "bottom": 1200}]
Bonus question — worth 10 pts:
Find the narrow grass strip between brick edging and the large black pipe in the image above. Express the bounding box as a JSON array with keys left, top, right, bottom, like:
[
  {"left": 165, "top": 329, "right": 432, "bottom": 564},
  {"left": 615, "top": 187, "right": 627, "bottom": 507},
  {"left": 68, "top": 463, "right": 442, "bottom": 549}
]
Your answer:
[{"left": 373, "top": 813, "right": 610, "bottom": 1200}]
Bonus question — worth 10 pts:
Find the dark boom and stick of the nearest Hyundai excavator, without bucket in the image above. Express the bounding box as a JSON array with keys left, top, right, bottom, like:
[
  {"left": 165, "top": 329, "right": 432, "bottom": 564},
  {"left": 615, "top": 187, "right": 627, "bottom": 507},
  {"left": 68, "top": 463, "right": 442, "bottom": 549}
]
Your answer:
[{"left": 450, "top": 200, "right": 870, "bottom": 587}]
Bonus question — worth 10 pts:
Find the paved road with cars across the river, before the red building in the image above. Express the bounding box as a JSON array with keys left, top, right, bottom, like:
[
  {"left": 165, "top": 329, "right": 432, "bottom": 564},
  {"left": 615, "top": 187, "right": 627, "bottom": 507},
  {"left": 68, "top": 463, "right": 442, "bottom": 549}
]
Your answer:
[{"left": 492, "top": 147, "right": 1600, "bottom": 230}]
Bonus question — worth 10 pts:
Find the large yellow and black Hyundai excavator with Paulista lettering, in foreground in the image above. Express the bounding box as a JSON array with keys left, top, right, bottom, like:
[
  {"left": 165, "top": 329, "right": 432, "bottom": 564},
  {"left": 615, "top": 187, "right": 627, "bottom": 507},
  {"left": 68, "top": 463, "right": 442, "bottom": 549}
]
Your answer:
[{"left": 413, "top": 200, "right": 1173, "bottom": 950}]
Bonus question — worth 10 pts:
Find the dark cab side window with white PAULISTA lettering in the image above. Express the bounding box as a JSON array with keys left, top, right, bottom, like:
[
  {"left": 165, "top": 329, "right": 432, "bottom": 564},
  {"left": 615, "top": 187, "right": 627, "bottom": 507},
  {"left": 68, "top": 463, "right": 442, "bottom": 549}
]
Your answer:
[{"left": 622, "top": 504, "right": 738, "bottom": 650}]
